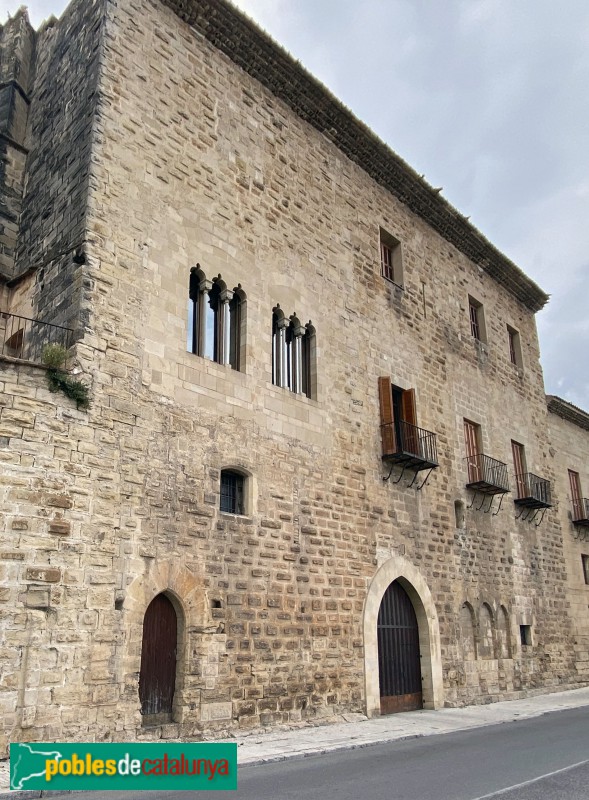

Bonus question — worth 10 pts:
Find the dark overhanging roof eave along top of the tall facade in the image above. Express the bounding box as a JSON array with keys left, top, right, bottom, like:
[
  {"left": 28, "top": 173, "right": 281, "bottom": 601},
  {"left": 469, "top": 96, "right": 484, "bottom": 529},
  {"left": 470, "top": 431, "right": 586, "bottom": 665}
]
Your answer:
[{"left": 162, "top": 0, "right": 548, "bottom": 312}]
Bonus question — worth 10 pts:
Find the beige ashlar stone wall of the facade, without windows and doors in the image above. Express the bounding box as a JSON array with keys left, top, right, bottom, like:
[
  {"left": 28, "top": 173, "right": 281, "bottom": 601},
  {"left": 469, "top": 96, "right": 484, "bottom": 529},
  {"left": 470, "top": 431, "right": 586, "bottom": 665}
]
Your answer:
[{"left": 0, "top": 0, "right": 578, "bottom": 752}]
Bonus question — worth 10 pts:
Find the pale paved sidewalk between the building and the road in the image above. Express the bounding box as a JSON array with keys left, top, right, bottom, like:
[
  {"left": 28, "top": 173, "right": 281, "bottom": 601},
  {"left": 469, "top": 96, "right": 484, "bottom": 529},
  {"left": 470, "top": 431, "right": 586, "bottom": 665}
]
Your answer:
[{"left": 0, "top": 687, "right": 589, "bottom": 800}]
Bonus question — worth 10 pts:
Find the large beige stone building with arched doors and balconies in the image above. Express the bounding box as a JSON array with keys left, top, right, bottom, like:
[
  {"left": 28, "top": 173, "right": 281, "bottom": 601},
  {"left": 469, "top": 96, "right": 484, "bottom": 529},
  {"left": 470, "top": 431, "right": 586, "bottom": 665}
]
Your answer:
[{"left": 0, "top": 0, "right": 589, "bottom": 750}]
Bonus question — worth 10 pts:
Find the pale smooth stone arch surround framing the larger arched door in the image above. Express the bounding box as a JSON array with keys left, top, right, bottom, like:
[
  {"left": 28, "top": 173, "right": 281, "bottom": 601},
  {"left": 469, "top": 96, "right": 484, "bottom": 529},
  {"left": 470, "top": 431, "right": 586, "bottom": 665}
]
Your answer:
[{"left": 364, "top": 556, "right": 444, "bottom": 717}]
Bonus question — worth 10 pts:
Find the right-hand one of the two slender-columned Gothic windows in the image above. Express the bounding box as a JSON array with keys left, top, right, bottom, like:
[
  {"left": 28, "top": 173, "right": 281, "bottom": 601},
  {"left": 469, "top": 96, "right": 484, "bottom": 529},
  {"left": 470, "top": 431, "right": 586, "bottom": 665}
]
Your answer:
[{"left": 272, "top": 305, "right": 315, "bottom": 404}]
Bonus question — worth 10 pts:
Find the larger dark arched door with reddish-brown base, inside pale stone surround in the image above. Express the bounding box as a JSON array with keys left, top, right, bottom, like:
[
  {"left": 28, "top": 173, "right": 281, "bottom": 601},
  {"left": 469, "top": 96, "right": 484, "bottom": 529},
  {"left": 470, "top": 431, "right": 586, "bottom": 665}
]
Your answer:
[{"left": 377, "top": 581, "right": 423, "bottom": 714}]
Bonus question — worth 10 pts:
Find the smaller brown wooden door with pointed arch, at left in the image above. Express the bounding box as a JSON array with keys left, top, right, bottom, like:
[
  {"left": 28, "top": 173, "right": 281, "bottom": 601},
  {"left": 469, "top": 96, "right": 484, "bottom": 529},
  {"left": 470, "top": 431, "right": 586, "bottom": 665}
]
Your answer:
[{"left": 139, "top": 594, "right": 178, "bottom": 715}]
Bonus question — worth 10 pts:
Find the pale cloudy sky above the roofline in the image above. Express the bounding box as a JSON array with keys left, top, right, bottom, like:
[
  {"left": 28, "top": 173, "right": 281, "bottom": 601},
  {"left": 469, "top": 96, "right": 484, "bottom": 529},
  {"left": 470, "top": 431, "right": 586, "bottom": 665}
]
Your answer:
[{"left": 0, "top": 0, "right": 589, "bottom": 410}]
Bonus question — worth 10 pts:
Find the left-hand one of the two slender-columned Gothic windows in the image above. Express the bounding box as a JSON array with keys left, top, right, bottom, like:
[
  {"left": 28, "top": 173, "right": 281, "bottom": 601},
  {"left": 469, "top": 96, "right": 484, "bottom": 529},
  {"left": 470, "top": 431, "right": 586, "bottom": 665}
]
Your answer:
[{"left": 186, "top": 264, "right": 245, "bottom": 370}]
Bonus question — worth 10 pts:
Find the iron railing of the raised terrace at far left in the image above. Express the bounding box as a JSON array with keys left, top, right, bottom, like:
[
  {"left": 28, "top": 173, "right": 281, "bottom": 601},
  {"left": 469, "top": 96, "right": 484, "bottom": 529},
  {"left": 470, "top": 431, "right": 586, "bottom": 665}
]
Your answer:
[{"left": 0, "top": 311, "right": 73, "bottom": 364}]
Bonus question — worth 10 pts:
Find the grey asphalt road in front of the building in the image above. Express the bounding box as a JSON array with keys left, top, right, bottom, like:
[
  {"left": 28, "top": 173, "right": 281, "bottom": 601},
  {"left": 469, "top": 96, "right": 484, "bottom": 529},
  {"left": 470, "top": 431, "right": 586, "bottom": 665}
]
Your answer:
[{"left": 50, "top": 708, "right": 589, "bottom": 800}]
